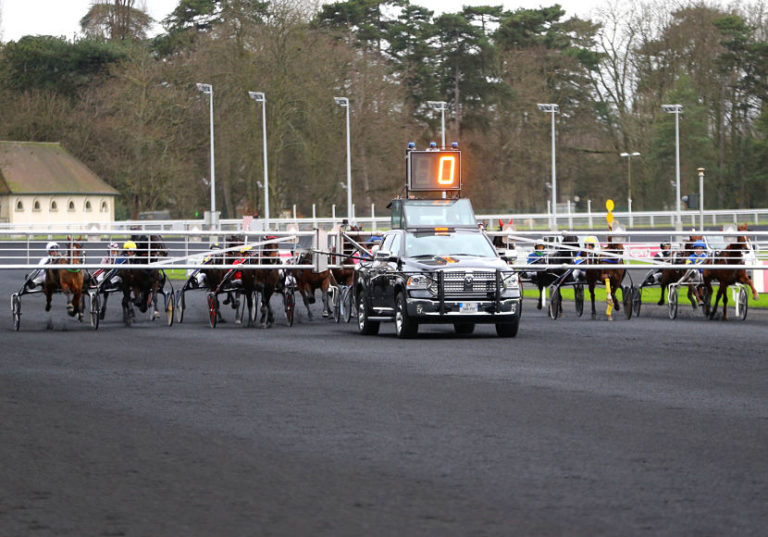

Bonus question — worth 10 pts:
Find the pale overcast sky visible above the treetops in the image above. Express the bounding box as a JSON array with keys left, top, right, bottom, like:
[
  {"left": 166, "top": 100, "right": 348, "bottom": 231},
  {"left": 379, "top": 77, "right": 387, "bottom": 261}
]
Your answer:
[{"left": 0, "top": 0, "right": 603, "bottom": 42}]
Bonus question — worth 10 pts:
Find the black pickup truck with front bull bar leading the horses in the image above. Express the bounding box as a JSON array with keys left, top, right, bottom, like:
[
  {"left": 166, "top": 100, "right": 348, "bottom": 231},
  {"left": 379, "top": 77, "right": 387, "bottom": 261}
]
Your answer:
[{"left": 355, "top": 213, "right": 522, "bottom": 338}]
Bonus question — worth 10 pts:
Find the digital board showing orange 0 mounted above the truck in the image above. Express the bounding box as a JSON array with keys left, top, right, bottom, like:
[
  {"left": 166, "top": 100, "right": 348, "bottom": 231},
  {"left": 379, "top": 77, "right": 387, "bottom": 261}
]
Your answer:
[{"left": 408, "top": 151, "right": 461, "bottom": 192}]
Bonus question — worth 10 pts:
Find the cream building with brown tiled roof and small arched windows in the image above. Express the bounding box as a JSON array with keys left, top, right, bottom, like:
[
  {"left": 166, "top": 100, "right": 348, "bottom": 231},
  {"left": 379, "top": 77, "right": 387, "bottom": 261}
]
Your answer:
[{"left": 0, "top": 141, "right": 120, "bottom": 225}]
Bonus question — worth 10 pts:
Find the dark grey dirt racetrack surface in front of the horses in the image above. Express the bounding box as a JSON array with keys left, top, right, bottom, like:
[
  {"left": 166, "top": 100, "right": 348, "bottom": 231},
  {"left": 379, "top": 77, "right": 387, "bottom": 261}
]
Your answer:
[{"left": 0, "top": 272, "right": 768, "bottom": 537}]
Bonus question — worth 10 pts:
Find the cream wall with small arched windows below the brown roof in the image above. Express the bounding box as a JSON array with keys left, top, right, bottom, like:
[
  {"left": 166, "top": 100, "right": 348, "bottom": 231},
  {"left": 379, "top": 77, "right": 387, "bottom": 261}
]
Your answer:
[{"left": 0, "top": 194, "right": 115, "bottom": 226}]
